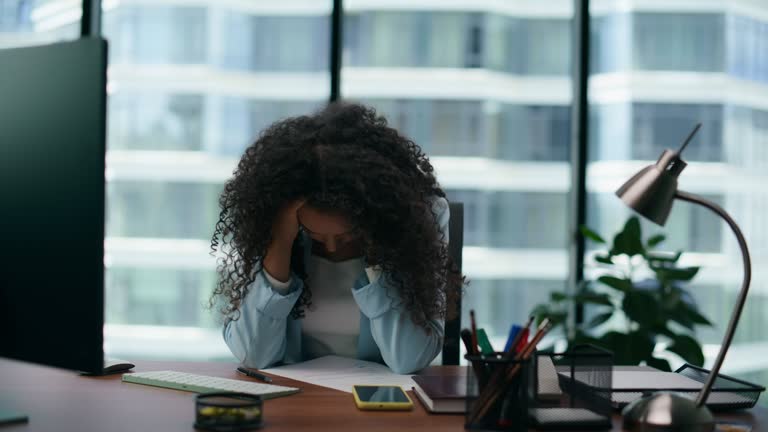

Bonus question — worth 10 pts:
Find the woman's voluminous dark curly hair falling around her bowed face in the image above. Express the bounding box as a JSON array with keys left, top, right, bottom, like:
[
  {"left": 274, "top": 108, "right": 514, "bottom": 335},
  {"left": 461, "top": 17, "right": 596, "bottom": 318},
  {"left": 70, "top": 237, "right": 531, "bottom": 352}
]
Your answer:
[{"left": 211, "top": 103, "right": 464, "bottom": 328}]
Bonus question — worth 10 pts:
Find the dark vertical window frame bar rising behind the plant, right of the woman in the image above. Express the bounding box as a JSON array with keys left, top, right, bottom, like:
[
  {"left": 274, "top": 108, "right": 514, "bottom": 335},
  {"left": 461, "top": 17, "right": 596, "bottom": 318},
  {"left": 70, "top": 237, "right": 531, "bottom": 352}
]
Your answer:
[{"left": 568, "top": 0, "right": 589, "bottom": 322}]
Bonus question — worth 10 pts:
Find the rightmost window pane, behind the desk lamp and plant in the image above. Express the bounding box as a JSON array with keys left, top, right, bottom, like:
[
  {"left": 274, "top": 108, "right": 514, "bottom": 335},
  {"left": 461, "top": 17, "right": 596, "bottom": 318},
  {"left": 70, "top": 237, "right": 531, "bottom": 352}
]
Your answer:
[{"left": 587, "top": 4, "right": 768, "bottom": 402}]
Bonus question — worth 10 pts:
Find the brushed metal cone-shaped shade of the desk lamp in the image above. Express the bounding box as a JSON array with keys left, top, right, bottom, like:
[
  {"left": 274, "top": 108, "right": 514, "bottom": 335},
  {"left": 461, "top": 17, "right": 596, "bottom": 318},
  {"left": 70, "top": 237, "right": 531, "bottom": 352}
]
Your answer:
[{"left": 616, "top": 150, "right": 686, "bottom": 226}]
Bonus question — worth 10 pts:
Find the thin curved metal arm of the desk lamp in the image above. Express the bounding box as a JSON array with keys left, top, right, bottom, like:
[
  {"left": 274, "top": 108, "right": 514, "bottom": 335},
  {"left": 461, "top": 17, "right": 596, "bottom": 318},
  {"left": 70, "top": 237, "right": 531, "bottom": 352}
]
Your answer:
[{"left": 675, "top": 190, "right": 752, "bottom": 407}]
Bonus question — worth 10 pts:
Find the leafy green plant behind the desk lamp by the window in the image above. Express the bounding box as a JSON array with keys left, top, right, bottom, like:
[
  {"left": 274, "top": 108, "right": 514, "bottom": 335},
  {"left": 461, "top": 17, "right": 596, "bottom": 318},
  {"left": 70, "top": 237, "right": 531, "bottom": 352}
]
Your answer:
[{"left": 532, "top": 216, "right": 712, "bottom": 371}]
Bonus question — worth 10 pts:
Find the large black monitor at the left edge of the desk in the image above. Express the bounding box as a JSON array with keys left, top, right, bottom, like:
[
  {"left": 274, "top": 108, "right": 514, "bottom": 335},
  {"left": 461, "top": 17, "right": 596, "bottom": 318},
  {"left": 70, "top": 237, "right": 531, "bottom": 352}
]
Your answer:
[{"left": 0, "top": 38, "right": 107, "bottom": 372}]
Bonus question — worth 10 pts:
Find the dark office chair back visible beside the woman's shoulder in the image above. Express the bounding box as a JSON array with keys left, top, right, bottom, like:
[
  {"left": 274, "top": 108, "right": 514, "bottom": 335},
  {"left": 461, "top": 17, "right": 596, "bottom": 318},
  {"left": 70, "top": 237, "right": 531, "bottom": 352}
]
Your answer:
[{"left": 443, "top": 202, "right": 464, "bottom": 365}]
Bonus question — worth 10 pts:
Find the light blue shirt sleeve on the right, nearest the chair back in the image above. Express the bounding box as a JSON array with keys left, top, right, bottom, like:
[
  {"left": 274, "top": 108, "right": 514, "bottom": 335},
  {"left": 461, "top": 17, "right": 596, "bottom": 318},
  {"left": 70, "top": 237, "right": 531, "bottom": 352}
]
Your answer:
[{"left": 352, "top": 198, "right": 450, "bottom": 374}]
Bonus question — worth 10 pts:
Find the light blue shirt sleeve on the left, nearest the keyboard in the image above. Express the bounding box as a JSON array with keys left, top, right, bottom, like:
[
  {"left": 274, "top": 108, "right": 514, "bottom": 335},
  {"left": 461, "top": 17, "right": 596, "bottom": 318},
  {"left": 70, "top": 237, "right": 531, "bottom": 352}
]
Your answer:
[{"left": 223, "top": 271, "right": 304, "bottom": 369}]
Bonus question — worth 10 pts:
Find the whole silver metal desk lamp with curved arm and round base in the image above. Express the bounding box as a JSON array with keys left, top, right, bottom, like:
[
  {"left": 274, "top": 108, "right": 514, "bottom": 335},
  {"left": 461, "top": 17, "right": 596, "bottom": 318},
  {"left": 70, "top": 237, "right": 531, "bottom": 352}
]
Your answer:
[{"left": 616, "top": 123, "right": 752, "bottom": 432}]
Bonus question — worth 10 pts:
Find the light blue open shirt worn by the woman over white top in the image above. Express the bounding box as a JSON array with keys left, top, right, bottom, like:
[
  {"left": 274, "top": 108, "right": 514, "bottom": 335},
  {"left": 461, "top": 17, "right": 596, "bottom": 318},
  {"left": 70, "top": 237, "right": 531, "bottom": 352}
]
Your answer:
[{"left": 224, "top": 198, "right": 450, "bottom": 374}]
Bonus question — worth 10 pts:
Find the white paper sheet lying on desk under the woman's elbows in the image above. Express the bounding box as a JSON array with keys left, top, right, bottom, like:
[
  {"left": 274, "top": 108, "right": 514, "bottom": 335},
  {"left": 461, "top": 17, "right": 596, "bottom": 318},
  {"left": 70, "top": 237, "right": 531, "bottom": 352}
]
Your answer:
[{"left": 263, "top": 356, "right": 413, "bottom": 393}]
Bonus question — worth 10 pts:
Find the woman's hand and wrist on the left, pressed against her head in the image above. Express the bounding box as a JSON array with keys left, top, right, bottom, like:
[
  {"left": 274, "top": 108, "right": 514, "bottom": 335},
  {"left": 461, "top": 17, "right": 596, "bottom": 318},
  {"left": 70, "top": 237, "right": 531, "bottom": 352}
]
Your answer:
[{"left": 264, "top": 200, "right": 305, "bottom": 282}]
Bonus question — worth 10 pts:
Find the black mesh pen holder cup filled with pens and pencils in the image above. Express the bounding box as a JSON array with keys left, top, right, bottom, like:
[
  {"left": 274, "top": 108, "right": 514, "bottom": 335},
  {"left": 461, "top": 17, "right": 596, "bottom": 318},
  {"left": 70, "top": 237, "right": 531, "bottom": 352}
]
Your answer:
[{"left": 464, "top": 353, "right": 531, "bottom": 432}]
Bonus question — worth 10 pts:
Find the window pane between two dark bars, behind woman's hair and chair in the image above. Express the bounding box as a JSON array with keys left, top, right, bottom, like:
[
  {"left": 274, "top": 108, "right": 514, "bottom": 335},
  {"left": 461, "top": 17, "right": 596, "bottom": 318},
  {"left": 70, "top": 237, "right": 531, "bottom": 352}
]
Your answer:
[{"left": 342, "top": 3, "right": 571, "bottom": 352}]
